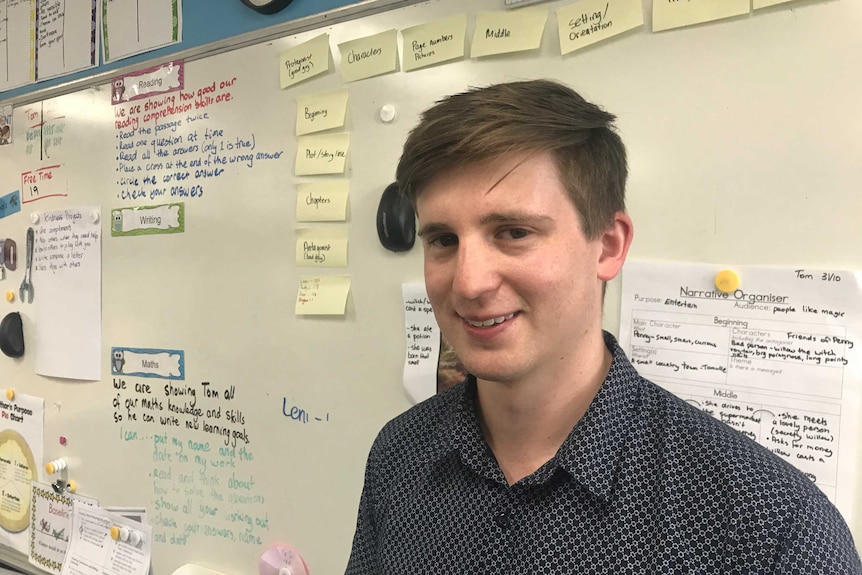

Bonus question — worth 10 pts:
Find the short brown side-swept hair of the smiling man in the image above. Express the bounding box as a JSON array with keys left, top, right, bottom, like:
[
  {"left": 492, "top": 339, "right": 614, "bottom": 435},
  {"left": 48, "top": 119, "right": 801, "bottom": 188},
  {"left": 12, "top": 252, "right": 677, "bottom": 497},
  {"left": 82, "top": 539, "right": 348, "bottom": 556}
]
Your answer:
[{"left": 396, "top": 80, "right": 628, "bottom": 239}]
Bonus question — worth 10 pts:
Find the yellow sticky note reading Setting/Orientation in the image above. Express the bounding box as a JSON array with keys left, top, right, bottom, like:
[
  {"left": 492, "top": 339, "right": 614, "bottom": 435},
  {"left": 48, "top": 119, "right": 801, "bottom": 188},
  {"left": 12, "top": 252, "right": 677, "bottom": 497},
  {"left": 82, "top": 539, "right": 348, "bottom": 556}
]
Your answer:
[{"left": 557, "top": 0, "right": 644, "bottom": 54}]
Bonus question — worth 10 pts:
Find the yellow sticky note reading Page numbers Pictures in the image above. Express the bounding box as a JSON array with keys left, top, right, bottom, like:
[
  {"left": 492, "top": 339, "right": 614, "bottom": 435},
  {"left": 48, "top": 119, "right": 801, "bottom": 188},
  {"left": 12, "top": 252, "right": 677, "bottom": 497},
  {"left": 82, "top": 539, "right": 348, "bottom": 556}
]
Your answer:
[{"left": 401, "top": 14, "right": 467, "bottom": 72}]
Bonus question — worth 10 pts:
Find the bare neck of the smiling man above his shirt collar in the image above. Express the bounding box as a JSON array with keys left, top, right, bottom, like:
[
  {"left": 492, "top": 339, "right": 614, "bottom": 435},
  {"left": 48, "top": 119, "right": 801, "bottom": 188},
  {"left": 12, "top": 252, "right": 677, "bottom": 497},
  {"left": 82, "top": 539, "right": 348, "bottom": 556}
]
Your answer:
[{"left": 477, "top": 335, "right": 612, "bottom": 485}]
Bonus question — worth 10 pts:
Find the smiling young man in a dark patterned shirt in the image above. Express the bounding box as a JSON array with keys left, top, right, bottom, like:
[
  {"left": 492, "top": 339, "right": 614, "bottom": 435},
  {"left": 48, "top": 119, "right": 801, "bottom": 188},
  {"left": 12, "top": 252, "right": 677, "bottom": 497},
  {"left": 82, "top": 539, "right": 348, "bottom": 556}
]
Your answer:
[{"left": 347, "top": 80, "right": 862, "bottom": 575}]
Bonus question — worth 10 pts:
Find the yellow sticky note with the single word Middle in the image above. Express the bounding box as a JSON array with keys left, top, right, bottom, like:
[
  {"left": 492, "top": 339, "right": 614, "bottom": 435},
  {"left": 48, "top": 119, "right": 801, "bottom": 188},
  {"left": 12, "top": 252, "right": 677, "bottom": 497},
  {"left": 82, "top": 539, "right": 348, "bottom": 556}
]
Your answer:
[{"left": 470, "top": 6, "right": 548, "bottom": 58}]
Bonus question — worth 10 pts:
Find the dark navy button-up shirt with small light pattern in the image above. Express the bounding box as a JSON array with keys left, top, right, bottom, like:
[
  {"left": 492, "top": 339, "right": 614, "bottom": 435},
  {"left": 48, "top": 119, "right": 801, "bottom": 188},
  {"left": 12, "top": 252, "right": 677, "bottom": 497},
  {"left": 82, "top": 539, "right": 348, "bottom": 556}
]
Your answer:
[{"left": 347, "top": 334, "right": 862, "bottom": 575}]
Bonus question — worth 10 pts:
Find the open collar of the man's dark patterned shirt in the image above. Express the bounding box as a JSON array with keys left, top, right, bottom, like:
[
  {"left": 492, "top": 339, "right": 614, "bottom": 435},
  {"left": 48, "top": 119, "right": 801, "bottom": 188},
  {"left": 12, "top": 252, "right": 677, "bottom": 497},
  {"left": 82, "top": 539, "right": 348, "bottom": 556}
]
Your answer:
[{"left": 431, "top": 332, "right": 639, "bottom": 500}]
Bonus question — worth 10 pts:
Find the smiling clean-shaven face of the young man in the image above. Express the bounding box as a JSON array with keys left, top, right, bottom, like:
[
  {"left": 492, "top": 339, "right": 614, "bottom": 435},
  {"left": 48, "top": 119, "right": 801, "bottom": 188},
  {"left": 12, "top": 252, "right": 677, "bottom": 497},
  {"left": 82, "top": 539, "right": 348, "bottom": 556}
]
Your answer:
[{"left": 416, "top": 153, "right": 627, "bottom": 388}]
